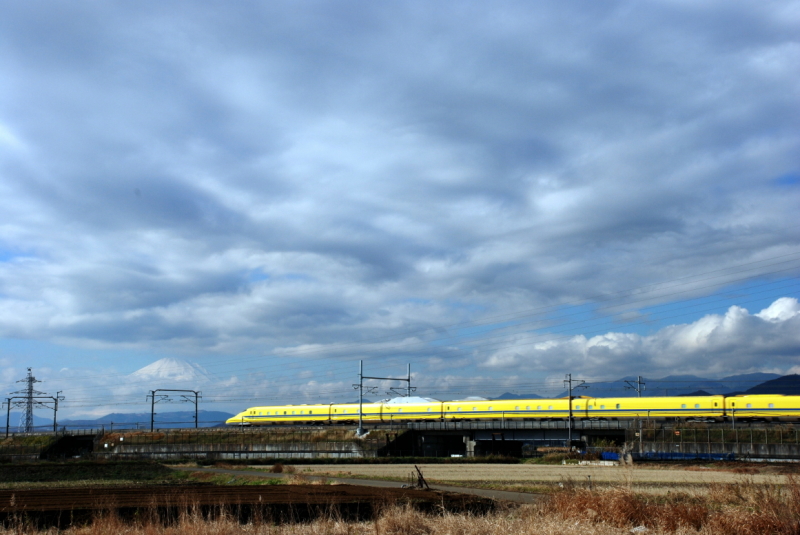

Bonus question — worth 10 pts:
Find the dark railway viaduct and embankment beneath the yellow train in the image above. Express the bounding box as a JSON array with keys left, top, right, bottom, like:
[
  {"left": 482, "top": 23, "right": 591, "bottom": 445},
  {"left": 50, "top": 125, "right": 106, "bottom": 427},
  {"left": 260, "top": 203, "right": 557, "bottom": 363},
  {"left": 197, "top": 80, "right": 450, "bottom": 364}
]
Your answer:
[{"left": 0, "top": 420, "right": 800, "bottom": 460}]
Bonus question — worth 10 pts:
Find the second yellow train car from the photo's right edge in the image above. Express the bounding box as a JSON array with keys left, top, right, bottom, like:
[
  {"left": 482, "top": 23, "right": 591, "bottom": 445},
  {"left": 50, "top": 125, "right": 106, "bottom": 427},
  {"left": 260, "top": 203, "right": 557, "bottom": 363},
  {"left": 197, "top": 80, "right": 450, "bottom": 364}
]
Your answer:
[{"left": 584, "top": 396, "right": 725, "bottom": 420}]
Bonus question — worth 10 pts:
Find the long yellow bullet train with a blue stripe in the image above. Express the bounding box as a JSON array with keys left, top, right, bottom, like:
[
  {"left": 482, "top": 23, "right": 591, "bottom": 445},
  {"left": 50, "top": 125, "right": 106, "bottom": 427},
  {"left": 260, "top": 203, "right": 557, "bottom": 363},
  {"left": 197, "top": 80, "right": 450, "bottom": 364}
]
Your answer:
[{"left": 226, "top": 395, "right": 800, "bottom": 425}]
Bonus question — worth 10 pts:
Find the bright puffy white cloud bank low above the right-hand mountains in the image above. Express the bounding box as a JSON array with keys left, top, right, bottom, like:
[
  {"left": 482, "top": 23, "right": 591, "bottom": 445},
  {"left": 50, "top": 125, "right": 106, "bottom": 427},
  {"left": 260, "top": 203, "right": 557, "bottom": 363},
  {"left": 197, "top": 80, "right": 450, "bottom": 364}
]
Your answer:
[{"left": 483, "top": 297, "right": 800, "bottom": 379}]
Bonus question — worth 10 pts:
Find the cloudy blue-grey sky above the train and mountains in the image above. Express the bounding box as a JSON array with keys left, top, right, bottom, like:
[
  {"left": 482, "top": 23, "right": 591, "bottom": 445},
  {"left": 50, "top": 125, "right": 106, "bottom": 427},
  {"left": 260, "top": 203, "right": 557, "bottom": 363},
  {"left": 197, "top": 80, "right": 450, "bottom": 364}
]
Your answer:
[{"left": 0, "top": 0, "right": 800, "bottom": 417}]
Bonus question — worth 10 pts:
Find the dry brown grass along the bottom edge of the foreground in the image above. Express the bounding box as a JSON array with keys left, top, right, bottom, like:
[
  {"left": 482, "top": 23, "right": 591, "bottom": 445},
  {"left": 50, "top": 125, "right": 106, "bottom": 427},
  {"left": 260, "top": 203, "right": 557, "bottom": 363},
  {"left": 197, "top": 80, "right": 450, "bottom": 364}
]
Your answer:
[{"left": 0, "top": 475, "right": 800, "bottom": 535}]
